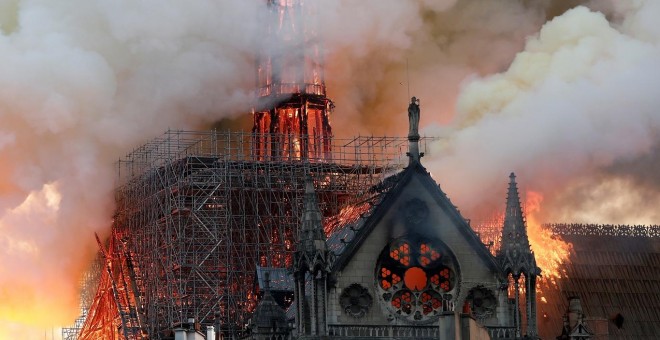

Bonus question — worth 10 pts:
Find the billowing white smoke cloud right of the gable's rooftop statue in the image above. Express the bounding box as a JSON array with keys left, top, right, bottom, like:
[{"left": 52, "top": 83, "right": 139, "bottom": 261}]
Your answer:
[{"left": 427, "top": 1, "right": 660, "bottom": 223}]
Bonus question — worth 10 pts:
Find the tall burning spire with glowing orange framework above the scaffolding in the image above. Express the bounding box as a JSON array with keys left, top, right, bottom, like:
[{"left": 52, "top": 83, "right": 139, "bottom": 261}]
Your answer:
[{"left": 252, "top": 0, "right": 334, "bottom": 160}]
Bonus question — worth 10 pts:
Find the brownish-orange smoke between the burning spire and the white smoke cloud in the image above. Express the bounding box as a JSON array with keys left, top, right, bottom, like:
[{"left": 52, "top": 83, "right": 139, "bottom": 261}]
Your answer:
[{"left": 321, "top": 0, "right": 551, "bottom": 136}]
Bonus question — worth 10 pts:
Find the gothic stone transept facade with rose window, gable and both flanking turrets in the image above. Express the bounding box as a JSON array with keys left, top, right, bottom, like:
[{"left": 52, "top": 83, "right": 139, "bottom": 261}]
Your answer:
[{"left": 250, "top": 107, "right": 539, "bottom": 339}]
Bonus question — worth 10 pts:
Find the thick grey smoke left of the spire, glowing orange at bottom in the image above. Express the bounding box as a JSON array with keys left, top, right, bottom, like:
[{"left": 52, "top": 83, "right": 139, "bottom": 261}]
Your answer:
[{"left": 0, "top": 0, "right": 264, "bottom": 339}]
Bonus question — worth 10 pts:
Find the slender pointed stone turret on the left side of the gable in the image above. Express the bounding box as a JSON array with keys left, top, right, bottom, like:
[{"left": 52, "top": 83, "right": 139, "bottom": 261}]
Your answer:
[{"left": 293, "top": 179, "right": 333, "bottom": 338}]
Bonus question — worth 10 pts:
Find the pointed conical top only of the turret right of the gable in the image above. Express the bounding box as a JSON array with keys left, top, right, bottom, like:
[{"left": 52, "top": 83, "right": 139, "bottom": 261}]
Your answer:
[{"left": 497, "top": 172, "right": 540, "bottom": 276}]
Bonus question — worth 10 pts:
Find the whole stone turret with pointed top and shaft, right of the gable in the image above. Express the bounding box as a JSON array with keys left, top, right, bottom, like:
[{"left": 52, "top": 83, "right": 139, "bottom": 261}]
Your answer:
[{"left": 497, "top": 173, "right": 541, "bottom": 338}]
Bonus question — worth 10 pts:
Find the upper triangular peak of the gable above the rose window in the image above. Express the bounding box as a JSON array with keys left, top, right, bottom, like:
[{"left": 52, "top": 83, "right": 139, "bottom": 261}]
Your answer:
[{"left": 326, "top": 163, "right": 499, "bottom": 271}]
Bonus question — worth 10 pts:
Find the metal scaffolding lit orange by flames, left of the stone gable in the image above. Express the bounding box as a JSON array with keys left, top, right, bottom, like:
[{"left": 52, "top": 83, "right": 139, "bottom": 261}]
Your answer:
[{"left": 72, "top": 131, "right": 434, "bottom": 339}]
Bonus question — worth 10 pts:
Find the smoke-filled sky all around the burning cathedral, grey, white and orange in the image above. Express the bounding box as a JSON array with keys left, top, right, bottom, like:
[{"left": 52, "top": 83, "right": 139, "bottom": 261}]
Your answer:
[{"left": 0, "top": 0, "right": 660, "bottom": 339}]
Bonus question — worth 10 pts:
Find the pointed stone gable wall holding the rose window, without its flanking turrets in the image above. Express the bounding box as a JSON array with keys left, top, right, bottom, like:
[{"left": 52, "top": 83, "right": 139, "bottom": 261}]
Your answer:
[{"left": 328, "top": 162, "right": 504, "bottom": 324}]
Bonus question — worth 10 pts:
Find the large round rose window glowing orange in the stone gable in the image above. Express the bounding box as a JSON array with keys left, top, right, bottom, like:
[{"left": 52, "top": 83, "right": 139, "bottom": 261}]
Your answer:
[{"left": 376, "top": 238, "right": 457, "bottom": 322}]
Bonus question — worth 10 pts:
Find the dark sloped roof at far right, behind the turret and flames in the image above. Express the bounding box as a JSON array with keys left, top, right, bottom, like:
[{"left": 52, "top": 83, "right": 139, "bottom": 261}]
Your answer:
[{"left": 538, "top": 225, "right": 660, "bottom": 340}]
